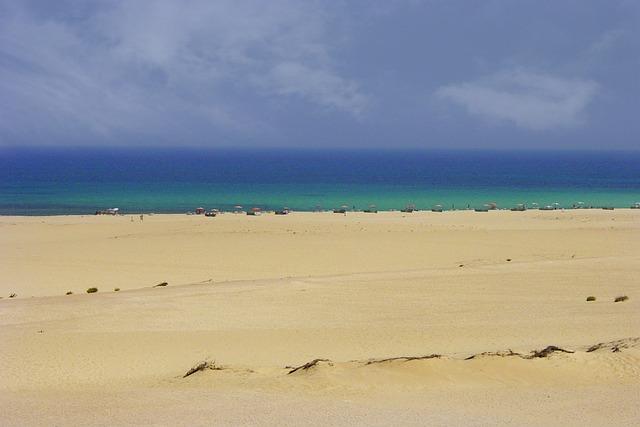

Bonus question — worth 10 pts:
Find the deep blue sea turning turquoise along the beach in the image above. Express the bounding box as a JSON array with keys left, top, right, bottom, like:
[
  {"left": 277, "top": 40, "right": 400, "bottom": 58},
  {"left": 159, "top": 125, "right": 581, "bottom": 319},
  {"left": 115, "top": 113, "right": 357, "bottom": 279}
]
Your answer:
[{"left": 0, "top": 148, "right": 640, "bottom": 215}]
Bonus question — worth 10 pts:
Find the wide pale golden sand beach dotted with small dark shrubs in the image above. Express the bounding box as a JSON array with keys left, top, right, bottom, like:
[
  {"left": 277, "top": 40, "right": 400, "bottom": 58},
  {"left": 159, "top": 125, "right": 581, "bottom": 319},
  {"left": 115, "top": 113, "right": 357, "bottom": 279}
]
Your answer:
[{"left": 0, "top": 209, "right": 640, "bottom": 426}]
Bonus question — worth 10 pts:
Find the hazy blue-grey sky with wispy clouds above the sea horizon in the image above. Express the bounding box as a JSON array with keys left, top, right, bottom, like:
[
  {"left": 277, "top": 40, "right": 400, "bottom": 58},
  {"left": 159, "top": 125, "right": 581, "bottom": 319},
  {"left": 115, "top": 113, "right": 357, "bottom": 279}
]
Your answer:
[{"left": 0, "top": 0, "right": 640, "bottom": 150}]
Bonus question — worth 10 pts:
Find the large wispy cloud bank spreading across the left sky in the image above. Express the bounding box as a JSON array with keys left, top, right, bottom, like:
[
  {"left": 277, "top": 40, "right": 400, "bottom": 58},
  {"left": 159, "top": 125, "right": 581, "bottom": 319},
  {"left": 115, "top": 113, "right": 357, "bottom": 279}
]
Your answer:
[{"left": 0, "top": 0, "right": 367, "bottom": 142}]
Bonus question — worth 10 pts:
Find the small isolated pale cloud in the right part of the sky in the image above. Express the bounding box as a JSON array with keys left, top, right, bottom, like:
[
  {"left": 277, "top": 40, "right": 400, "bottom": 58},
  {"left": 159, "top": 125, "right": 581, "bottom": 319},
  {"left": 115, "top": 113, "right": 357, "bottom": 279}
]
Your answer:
[{"left": 436, "top": 70, "right": 598, "bottom": 130}]
